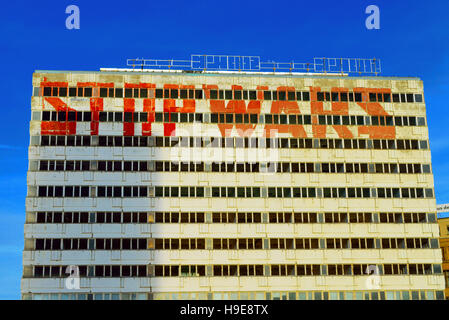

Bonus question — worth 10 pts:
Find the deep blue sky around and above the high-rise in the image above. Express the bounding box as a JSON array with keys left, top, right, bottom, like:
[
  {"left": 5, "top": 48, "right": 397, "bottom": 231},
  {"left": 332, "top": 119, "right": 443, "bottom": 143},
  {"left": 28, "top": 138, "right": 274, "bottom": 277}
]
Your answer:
[{"left": 0, "top": 0, "right": 449, "bottom": 299}]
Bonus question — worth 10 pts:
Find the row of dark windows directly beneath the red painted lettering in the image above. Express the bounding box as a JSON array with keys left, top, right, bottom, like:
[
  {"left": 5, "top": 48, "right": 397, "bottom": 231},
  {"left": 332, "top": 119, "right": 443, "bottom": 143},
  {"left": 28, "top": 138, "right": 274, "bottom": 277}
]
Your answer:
[{"left": 35, "top": 135, "right": 428, "bottom": 150}]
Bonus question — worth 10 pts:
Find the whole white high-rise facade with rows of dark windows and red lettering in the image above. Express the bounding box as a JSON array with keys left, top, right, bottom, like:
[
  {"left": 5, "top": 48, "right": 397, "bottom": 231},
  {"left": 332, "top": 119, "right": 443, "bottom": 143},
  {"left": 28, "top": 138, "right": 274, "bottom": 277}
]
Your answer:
[{"left": 21, "top": 70, "right": 444, "bottom": 300}]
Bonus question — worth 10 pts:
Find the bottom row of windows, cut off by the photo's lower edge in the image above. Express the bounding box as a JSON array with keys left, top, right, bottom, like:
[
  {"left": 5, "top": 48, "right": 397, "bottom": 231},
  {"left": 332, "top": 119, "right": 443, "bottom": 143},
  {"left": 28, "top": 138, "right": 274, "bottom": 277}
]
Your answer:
[{"left": 22, "top": 290, "right": 444, "bottom": 300}]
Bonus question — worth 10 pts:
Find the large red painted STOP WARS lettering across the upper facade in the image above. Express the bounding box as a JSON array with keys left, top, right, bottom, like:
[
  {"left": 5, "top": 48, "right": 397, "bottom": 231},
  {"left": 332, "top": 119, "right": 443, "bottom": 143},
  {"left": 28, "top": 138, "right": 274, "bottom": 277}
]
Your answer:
[{"left": 36, "top": 78, "right": 396, "bottom": 139}]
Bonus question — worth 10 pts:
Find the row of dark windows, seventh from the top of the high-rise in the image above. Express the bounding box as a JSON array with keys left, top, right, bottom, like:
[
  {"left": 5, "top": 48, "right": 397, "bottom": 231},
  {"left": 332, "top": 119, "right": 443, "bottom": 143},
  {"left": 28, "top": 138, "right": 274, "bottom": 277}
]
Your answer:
[{"left": 35, "top": 238, "right": 439, "bottom": 250}]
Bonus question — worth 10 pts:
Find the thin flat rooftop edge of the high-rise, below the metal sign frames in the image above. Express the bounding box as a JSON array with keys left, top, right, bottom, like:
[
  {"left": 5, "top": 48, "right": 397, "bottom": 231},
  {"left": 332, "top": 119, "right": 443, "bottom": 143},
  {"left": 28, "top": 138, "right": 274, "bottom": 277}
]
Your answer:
[{"left": 34, "top": 68, "right": 421, "bottom": 80}]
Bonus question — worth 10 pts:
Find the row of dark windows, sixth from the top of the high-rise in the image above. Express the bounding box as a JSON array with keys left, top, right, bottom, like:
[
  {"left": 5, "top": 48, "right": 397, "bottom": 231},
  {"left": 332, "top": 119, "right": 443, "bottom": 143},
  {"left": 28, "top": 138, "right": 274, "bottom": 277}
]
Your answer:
[{"left": 36, "top": 211, "right": 436, "bottom": 223}]
